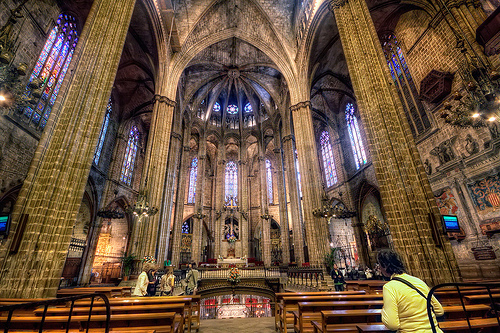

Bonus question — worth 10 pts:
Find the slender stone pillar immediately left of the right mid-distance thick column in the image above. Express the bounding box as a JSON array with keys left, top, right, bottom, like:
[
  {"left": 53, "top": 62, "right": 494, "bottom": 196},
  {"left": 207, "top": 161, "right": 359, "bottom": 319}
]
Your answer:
[{"left": 281, "top": 134, "right": 304, "bottom": 265}]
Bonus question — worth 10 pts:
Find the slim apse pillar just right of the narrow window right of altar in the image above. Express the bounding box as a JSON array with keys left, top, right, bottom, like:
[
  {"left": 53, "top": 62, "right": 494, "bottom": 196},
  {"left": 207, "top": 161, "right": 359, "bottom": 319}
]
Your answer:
[{"left": 274, "top": 148, "right": 290, "bottom": 264}]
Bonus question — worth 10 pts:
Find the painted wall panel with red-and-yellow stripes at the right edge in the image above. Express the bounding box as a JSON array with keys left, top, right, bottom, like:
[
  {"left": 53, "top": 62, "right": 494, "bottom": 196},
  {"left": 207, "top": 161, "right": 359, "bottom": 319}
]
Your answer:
[{"left": 467, "top": 175, "right": 500, "bottom": 215}]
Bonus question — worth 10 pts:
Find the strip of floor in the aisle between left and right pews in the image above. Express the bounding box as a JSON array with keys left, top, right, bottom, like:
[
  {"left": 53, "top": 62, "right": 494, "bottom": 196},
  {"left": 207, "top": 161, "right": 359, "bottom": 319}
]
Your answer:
[{"left": 200, "top": 317, "right": 275, "bottom": 333}]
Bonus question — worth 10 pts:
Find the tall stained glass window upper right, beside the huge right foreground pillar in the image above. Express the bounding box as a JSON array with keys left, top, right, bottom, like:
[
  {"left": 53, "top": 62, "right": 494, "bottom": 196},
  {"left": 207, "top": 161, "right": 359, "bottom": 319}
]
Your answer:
[{"left": 382, "top": 34, "right": 431, "bottom": 137}]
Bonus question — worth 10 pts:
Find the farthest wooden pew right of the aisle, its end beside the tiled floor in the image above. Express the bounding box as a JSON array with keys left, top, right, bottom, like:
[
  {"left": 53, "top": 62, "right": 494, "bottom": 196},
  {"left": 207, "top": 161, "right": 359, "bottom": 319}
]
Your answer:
[{"left": 278, "top": 294, "right": 382, "bottom": 333}]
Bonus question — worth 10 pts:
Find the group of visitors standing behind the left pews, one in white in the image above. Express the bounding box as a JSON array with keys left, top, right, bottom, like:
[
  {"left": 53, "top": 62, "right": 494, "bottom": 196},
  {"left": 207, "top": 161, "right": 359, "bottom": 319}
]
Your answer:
[{"left": 132, "top": 262, "right": 200, "bottom": 296}]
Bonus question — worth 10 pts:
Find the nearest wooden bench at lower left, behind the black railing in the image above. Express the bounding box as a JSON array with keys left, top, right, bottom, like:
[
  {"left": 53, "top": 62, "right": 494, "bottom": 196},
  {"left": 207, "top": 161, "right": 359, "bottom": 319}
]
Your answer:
[{"left": 0, "top": 312, "right": 181, "bottom": 333}]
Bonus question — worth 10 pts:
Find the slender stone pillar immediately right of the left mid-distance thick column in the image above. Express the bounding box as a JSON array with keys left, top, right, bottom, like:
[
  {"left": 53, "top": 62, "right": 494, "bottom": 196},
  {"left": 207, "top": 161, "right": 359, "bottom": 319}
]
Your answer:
[{"left": 172, "top": 127, "right": 190, "bottom": 267}]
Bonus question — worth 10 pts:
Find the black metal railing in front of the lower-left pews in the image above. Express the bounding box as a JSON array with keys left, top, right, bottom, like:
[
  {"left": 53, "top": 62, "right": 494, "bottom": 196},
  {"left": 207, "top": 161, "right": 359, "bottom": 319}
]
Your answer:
[{"left": 0, "top": 293, "right": 111, "bottom": 333}]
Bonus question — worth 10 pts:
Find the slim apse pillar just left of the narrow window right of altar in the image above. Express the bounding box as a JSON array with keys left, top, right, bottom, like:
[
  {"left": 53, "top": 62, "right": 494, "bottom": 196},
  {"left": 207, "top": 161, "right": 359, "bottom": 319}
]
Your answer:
[{"left": 259, "top": 153, "right": 271, "bottom": 267}]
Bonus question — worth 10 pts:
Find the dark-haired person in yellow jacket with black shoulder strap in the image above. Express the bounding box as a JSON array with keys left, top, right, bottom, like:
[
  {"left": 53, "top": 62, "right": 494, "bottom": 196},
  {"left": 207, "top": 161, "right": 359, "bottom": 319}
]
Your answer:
[{"left": 377, "top": 249, "right": 444, "bottom": 333}]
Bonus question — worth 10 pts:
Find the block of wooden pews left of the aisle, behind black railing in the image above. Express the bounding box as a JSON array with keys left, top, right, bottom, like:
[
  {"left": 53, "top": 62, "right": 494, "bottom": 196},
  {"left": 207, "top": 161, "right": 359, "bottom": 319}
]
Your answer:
[{"left": 0, "top": 296, "right": 200, "bottom": 333}]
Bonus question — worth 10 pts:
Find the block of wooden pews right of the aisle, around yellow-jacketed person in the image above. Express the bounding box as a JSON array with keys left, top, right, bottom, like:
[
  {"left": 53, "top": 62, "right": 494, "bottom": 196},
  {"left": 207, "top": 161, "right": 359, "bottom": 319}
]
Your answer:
[{"left": 276, "top": 286, "right": 500, "bottom": 333}]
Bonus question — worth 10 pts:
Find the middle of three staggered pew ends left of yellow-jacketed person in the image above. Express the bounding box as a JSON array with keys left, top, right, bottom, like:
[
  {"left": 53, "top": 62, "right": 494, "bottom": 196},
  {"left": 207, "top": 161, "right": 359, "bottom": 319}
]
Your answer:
[{"left": 293, "top": 300, "right": 384, "bottom": 333}]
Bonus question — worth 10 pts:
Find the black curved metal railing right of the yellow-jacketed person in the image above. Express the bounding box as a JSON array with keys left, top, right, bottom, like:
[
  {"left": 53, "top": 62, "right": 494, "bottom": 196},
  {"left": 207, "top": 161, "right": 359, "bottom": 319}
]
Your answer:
[{"left": 427, "top": 283, "right": 500, "bottom": 333}]
